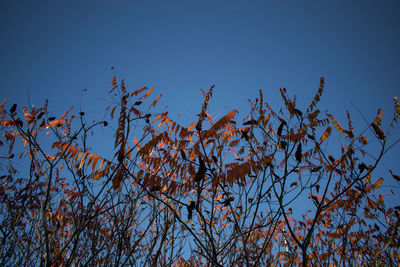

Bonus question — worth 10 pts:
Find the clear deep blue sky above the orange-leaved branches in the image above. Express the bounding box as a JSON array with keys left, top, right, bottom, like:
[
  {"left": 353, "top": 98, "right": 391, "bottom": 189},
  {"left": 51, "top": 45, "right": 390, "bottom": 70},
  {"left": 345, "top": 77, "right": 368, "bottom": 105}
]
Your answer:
[{"left": 0, "top": 0, "right": 400, "bottom": 203}]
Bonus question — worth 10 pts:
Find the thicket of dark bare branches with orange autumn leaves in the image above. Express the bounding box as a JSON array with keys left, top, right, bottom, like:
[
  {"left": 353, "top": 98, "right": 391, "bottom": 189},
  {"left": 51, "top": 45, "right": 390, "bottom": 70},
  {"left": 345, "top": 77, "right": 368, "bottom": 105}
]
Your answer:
[{"left": 0, "top": 78, "right": 400, "bottom": 266}]
